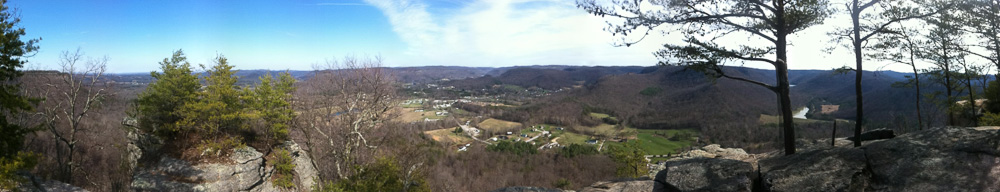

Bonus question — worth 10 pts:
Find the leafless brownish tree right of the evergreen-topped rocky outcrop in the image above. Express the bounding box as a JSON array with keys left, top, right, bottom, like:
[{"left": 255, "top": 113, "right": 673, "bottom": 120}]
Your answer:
[{"left": 297, "top": 57, "right": 397, "bottom": 179}]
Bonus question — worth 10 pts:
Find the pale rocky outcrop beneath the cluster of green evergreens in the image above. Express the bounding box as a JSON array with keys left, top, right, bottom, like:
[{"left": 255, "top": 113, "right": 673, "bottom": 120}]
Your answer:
[{"left": 132, "top": 142, "right": 318, "bottom": 191}]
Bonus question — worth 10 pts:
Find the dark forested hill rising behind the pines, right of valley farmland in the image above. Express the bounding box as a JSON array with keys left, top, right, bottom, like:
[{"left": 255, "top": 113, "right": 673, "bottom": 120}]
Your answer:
[{"left": 448, "top": 66, "right": 944, "bottom": 151}]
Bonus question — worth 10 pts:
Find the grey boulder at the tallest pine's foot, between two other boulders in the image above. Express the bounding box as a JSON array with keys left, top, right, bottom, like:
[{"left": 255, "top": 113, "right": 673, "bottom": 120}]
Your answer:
[{"left": 759, "top": 148, "right": 867, "bottom": 191}]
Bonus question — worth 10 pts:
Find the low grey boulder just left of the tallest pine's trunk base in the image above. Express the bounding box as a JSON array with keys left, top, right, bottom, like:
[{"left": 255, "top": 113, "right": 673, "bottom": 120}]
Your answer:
[{"left": 654, "top": 158, "right": 757, "bottom": 191}]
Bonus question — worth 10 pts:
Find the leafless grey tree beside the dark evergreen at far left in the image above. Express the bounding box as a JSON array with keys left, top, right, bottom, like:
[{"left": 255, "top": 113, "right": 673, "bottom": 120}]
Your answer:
[{"left": 30, "top": 49, "right": 109, "bottom": 183}]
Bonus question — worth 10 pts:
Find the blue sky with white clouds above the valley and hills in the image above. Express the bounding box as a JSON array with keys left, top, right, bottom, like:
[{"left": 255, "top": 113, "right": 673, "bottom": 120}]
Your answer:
[{"left": 9, "top": 0, "right": 928, "bottom": 73}]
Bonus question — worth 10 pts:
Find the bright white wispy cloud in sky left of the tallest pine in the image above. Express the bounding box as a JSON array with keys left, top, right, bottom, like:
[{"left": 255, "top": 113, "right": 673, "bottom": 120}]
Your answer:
[{"left": 366, "top": 0, "right": 660, "bottom": 66}]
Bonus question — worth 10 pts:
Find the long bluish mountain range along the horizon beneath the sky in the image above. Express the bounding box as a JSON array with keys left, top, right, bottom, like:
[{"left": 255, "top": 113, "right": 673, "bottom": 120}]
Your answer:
[{"left": 109, "top": 66, "right": 952, "bottom": 128}]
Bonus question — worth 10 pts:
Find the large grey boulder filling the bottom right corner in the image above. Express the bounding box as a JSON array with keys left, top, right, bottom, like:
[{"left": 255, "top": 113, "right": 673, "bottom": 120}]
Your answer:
[{"left": 865, "top": 128, "right": 1000, "bottom": 191}]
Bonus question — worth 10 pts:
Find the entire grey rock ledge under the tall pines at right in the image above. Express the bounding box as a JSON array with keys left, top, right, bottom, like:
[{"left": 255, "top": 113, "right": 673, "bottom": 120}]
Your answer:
[{"left": 654, "top": 127, "right": 1000, "bottom": 191}]
